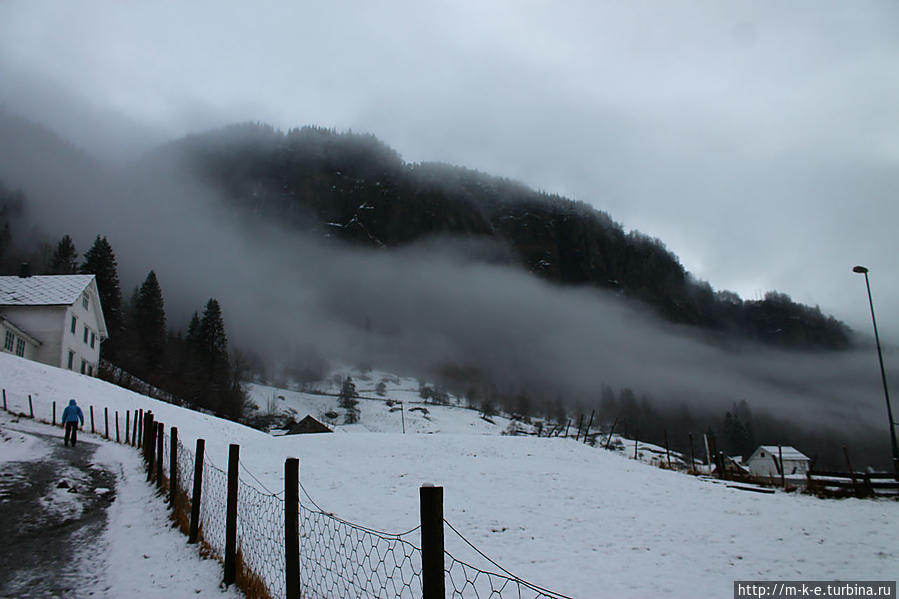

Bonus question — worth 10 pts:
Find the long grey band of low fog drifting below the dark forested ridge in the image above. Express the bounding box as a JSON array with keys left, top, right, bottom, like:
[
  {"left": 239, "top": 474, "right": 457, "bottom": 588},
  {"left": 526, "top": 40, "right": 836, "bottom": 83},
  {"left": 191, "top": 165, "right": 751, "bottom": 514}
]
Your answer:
[{"left": 0, "top": 111, "right": 891, "bottom": 440}]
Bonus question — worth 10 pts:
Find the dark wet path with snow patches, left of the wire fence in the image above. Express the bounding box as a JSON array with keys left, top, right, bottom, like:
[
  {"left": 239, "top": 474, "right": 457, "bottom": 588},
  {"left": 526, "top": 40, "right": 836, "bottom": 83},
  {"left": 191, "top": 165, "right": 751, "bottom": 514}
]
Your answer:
[{"left": 0, "top": 427, "right": 116, "bottom": 597}]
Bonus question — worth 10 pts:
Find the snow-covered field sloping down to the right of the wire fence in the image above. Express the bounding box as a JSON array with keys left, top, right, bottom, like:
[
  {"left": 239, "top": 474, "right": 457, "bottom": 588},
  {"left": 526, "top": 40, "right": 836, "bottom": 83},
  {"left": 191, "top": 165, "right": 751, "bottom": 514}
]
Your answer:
[{"left": 0, "top": 354, "right": 899, "bottom": 598}]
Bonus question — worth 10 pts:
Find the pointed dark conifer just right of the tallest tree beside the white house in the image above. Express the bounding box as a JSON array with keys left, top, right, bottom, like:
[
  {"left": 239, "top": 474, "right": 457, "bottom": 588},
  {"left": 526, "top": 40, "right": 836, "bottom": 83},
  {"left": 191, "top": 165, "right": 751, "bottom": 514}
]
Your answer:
[{"left": 129, "top": 270, "right": 166, "bottom": 378}]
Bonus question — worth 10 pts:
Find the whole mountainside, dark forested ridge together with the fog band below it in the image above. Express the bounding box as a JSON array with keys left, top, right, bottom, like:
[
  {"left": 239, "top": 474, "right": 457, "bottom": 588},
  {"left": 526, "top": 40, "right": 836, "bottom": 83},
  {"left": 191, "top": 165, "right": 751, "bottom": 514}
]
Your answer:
[{"left": 0, "top": 115, "right": 889, "bottom": 468}]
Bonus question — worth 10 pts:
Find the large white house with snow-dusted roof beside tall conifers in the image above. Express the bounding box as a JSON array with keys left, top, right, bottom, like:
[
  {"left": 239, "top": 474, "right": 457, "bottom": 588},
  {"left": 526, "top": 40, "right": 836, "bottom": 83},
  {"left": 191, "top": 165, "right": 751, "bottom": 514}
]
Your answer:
[{"left": 0, "top": 275, "right": 109, "bottom": 376}]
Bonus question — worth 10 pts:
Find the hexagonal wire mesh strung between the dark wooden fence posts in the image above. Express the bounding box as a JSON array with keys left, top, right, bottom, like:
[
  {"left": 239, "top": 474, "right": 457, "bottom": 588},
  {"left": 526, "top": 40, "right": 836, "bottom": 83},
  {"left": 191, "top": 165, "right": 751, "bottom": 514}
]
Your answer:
[{"left": 147, "top": 434, "right": 571, "bottom": 599}]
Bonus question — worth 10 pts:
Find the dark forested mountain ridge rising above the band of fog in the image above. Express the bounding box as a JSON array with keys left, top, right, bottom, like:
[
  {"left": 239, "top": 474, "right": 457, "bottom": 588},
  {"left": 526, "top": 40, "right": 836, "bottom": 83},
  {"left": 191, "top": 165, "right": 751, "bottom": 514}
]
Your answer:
[{"left": 160, "top": 124, "right": 850, "bottom": 349}]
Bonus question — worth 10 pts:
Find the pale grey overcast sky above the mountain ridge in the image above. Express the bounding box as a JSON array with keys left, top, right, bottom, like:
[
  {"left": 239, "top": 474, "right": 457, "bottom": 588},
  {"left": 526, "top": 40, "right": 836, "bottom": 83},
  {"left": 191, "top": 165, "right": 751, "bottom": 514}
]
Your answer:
[{"left": 0, "top": 0, "right": 899, "bottom": 342}]
